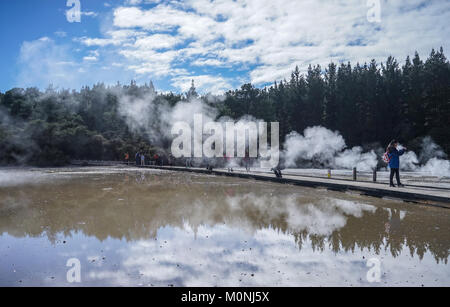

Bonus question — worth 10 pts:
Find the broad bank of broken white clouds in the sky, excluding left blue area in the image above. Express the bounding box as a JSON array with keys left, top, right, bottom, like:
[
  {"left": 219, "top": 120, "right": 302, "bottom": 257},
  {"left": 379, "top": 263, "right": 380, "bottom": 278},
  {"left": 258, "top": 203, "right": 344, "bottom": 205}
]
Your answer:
[{"left": 14, "top": 0, "right": 450, "bottom": 91}]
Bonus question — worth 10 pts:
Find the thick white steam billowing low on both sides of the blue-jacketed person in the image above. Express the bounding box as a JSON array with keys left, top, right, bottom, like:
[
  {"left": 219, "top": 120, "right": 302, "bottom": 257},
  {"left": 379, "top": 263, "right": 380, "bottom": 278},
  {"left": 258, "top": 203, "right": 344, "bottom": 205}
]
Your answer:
[{"left": 283, "top": 126, "right": 450, "bottom": 177}]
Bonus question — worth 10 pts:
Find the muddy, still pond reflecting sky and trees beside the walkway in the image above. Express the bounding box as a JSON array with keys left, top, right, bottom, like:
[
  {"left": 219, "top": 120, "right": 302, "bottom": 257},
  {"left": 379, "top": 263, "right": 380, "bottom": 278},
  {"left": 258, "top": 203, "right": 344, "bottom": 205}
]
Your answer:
[{"left": 0, "top": 168, "right": 450, "bottom": 286}]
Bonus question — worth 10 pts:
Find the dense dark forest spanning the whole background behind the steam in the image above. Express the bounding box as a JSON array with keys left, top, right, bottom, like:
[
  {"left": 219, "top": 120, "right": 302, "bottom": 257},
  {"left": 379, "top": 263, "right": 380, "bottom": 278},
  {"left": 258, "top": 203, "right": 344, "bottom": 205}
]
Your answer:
[{"left": 0, "top": 48, "right": 450, "bottom": 166}]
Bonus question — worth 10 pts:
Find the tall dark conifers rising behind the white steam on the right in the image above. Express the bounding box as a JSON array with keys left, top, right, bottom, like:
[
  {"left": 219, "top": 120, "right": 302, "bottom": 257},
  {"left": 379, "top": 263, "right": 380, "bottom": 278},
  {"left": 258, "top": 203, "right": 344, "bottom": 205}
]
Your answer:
[{"left": 221, "top": 48, "right": 450, "bottom": 153}]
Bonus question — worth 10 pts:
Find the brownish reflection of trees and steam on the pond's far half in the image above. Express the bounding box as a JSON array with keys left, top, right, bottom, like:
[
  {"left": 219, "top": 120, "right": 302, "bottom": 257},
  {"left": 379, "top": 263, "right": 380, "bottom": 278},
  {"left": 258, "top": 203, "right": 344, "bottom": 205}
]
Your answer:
[{"left": 0, "top": 171, "right": 450, "bottom": 264}]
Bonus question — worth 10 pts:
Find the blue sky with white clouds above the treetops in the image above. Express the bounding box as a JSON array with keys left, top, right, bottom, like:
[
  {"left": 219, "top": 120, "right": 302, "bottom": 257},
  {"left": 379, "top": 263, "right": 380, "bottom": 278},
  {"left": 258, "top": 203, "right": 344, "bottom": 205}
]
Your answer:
[{"left": 0, "top": 0, "right": 450, "bottom": 94}]
